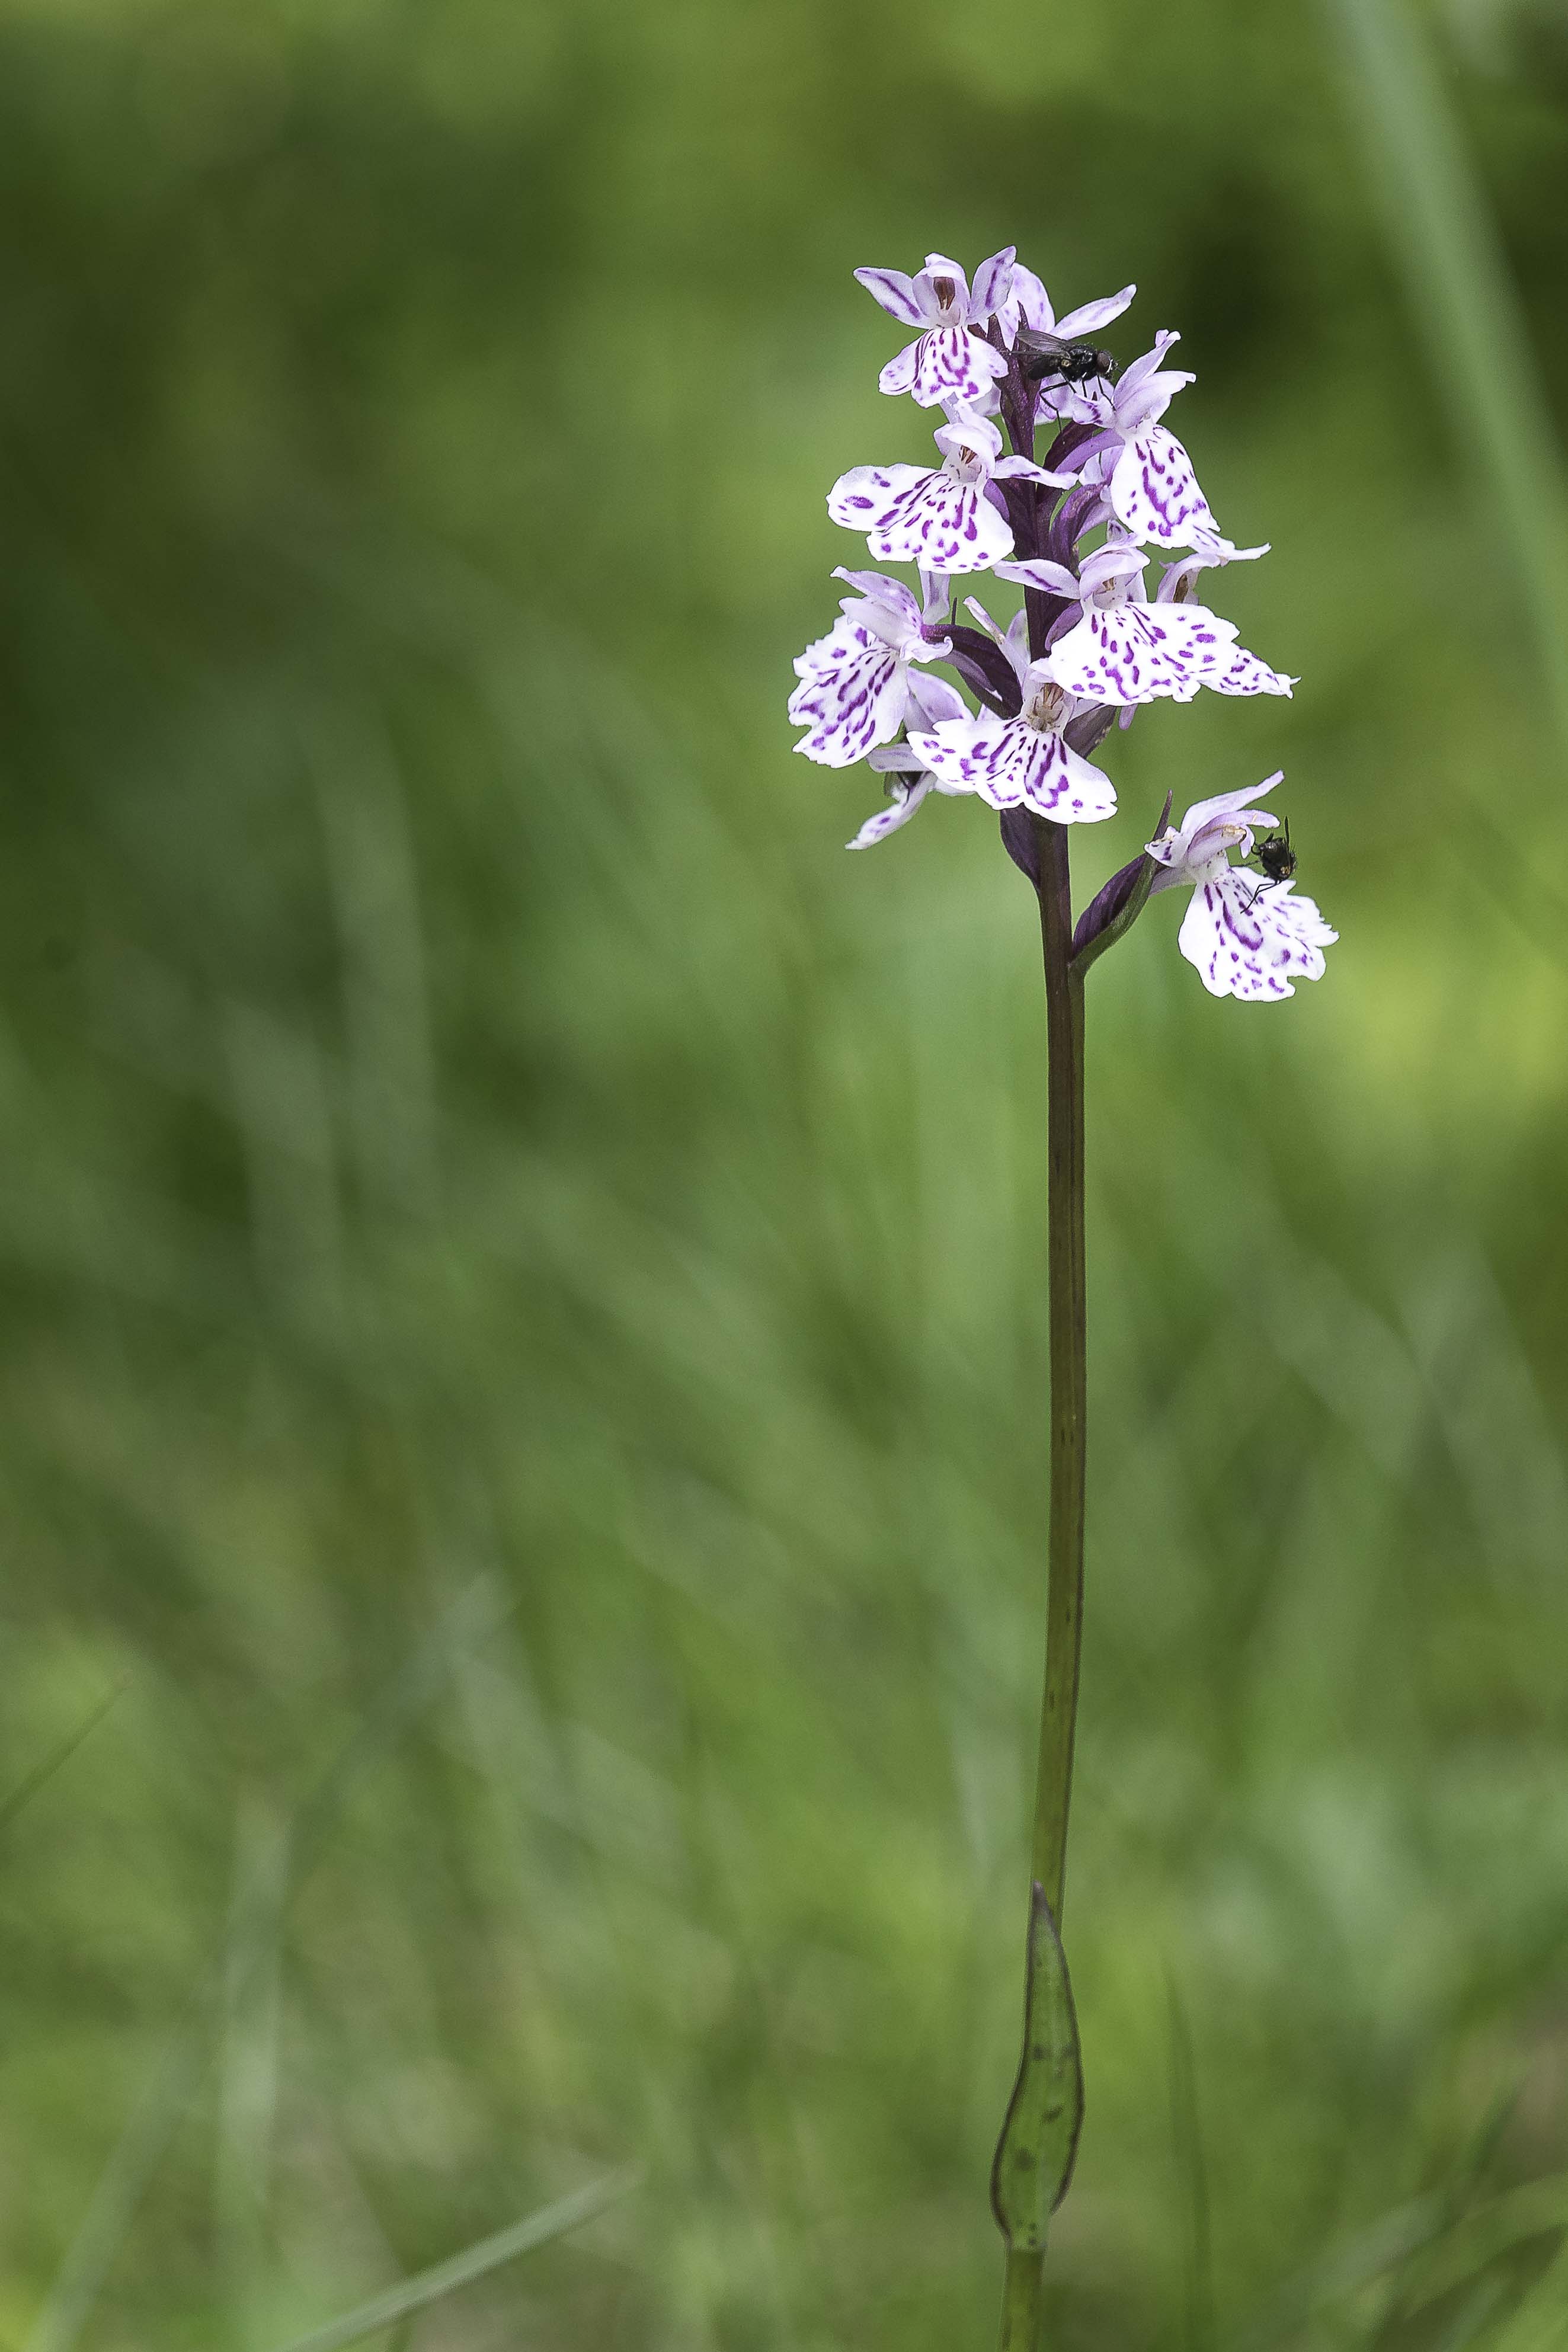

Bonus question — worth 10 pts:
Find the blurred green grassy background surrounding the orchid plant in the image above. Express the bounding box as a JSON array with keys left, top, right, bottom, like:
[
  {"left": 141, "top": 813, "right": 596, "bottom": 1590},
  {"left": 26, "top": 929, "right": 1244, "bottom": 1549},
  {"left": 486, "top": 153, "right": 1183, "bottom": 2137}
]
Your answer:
[{"left": 0, "top": 0, "right": 1568, "bottom": 2352}]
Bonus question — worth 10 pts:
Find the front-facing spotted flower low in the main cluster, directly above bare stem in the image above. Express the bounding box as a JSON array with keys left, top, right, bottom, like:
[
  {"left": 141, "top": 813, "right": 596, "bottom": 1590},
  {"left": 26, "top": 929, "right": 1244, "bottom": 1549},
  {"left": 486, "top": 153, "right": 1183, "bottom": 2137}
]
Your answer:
[{"left": 910, "top": 597, "right": 1116, "bottom": 825}]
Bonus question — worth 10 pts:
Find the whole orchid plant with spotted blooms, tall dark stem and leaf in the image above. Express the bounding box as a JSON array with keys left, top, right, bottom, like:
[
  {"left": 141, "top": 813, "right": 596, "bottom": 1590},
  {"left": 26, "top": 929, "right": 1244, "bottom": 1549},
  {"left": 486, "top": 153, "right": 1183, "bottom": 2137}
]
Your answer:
[{"left": 790, "top": 247, "right": 1337, "bottom": 2352}]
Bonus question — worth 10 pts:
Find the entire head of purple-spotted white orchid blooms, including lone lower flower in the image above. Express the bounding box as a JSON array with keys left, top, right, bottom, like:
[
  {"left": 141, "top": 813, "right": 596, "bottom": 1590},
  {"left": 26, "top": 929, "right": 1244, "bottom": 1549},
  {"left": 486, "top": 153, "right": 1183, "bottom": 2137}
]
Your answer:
[{"left": 790, "top": 247, "right": 1335, "bottom": 1000}]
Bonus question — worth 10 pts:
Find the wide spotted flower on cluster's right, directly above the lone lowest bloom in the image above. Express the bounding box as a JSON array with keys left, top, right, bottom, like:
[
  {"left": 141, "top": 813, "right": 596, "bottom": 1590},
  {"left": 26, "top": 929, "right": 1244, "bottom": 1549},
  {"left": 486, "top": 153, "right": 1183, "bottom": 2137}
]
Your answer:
[{"left": 997, "top": 541, "right": 1295, "bottom": 708}]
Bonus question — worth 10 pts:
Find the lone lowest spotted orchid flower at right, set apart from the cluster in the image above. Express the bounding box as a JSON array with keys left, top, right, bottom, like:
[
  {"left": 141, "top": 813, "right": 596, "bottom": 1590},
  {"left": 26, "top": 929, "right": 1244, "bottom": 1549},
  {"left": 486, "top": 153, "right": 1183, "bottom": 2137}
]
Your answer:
[{"left": 1147, "top": 772, "right": 1340, "bottom": 1002}]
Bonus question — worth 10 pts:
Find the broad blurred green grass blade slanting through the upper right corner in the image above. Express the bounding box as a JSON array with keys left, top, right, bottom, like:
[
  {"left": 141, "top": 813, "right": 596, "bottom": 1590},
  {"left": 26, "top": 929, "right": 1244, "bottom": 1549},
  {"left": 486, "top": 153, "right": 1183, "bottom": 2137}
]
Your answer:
[{"left": 1326, "top": 0, "right": 1568, "bottom": 745}]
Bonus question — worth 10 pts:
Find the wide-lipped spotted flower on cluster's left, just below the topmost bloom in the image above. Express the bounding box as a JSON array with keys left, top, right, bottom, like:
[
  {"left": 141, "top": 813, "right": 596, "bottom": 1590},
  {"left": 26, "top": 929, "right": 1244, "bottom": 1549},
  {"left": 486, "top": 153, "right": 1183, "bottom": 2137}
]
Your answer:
[{"left": 827, "top": 412, "right": 1070, "bottom": 571}]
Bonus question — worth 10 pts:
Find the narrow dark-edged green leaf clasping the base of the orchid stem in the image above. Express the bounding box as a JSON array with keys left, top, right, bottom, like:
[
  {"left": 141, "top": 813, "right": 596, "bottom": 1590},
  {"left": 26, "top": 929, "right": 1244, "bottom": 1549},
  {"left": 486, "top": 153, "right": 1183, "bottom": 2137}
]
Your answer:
[{"left": 992, "top": 1881, "right": 1084, "bottom": 2253}]
